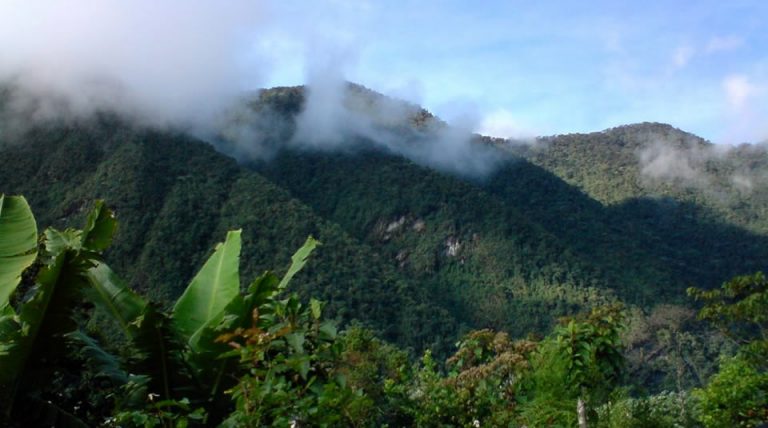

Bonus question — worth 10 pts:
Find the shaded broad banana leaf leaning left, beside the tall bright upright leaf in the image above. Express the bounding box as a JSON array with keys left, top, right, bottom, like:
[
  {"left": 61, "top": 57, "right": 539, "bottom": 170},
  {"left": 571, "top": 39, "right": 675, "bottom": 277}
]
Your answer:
[{"left": 86, "top": 263, "right": 147, "bottom": 339}]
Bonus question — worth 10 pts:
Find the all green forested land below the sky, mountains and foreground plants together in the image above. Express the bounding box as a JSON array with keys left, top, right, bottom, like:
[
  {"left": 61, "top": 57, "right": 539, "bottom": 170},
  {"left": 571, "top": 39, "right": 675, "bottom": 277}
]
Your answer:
[{"left": 0, "top": 86, "right": 768, "bottom": 427}]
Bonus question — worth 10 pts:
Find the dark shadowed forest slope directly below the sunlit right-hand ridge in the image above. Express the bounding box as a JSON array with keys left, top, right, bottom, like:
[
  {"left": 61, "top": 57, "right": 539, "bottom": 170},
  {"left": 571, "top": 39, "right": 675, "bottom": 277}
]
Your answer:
[{"left": 483, "top": 155, "right": 768, "bottom": 300}]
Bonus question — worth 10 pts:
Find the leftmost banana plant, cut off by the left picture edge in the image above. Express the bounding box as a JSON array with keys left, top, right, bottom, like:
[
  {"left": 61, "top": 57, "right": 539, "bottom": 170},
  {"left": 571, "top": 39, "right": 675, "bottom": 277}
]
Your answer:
[{"left": 0, "top": 195, "right": 115, "bottom": 426}]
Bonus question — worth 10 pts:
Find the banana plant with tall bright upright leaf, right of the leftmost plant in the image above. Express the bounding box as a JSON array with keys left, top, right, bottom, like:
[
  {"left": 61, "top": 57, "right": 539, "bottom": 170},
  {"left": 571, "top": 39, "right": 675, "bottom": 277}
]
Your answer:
[{"left": 75, "top": 214, "right": 317, "bottom": 423}]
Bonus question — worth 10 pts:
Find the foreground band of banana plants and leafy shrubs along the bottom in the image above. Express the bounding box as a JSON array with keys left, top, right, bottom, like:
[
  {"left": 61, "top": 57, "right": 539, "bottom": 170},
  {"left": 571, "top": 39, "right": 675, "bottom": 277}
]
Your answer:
[{"left": 0, "top": 195, "right": 768, "bottom": 427}]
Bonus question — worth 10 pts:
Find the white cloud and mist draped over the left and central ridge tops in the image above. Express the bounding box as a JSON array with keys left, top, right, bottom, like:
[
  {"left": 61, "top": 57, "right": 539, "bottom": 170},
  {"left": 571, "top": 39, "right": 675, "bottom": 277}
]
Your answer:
[{"left": 0, "top": 0, "right": 510, "bottom": 175}]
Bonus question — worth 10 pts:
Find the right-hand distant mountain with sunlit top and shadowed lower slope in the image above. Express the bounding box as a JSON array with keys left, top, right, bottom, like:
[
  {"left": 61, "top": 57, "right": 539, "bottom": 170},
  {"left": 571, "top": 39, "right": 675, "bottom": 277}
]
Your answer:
[{"left": 504, "top": 123, "right": 768, "bottom": 296}]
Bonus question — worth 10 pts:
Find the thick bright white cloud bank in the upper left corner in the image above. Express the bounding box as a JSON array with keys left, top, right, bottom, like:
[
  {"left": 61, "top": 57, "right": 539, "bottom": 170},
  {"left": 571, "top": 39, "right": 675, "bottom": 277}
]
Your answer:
[{"left": 0, "top": 0, "right": 264, "bottom": 127}]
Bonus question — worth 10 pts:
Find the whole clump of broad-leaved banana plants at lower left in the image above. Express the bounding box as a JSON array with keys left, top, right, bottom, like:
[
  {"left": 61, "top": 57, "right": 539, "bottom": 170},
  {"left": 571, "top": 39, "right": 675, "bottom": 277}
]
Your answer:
[{"left": 0, "top": 195, "right": 317, "bottom": 426}]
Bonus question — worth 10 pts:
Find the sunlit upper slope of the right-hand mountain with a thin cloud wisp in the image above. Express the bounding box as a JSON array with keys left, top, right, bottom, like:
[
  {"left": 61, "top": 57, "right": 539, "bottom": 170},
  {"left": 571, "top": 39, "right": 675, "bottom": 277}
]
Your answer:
[{"left": 520, "top": 123, "right": 768, "bottom": 234}]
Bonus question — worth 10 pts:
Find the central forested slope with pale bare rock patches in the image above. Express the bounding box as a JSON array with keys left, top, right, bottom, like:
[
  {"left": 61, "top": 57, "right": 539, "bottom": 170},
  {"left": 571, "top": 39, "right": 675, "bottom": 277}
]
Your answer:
[{"left": 259, "top": 151, "right": 612, "bottom": 334}]
